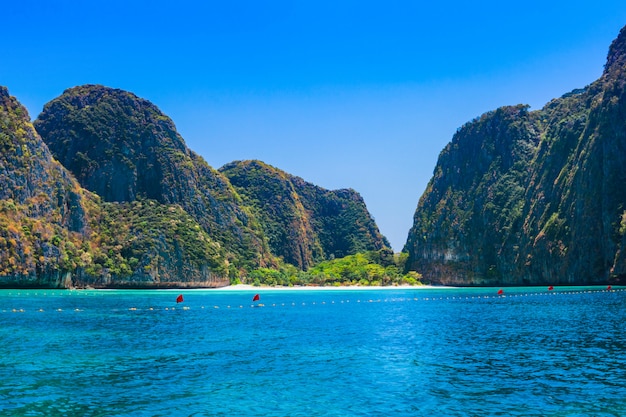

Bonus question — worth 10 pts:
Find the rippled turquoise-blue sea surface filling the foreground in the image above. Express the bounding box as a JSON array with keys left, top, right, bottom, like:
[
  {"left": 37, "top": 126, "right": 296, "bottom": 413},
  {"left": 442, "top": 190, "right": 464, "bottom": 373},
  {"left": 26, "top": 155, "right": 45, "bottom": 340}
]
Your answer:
[{"left": 0, "top": 287, "right": 626, "bottom": 417}]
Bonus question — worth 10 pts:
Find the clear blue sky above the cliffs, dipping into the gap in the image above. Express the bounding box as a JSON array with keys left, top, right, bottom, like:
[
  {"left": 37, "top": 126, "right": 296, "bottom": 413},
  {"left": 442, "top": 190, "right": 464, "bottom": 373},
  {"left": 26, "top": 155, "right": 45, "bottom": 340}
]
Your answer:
[{"left": 0, "top": 0, "right": 626, "bottom": 251}]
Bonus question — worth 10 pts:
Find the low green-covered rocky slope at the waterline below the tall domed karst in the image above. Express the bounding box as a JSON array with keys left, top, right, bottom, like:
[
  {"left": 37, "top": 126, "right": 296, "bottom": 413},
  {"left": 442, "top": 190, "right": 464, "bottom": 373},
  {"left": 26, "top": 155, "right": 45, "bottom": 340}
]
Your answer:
[{"left": 81, "top": 200, "right": 229, "bottom": 287}]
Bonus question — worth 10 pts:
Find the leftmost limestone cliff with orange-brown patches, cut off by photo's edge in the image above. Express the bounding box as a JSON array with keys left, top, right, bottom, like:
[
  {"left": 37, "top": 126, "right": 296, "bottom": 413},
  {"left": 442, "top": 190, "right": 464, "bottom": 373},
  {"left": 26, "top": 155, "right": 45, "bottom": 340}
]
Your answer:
[{"left": 0, "top": 87, "right": 88, "bottom": 288}]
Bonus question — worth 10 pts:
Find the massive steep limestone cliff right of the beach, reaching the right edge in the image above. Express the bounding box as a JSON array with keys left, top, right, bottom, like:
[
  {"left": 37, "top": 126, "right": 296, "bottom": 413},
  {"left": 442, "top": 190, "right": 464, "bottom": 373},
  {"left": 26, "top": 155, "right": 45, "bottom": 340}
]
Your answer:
[{"left": 404, "top": 28, "right": 626, "bottom": 285}]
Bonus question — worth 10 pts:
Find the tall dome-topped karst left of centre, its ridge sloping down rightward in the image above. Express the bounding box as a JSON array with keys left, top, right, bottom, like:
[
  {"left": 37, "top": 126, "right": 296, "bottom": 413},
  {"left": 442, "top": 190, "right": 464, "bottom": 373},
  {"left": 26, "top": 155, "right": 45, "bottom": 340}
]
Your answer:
[{"left": 34, "top": 85, "right": 274, "bottom": 274}]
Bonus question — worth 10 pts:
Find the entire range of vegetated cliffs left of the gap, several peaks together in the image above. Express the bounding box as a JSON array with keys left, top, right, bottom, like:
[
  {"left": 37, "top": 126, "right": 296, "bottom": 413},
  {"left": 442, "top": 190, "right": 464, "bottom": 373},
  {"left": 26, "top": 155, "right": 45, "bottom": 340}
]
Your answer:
[{"left": 0, "top": 85, "right": 388, "bottom": 288}]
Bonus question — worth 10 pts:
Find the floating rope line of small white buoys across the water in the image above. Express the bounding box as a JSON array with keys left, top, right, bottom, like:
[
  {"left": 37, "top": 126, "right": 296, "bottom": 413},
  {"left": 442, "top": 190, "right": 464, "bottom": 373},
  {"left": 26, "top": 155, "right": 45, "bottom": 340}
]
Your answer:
[{"left": 0, "top": 288, "right": 626, "bottom": 314}]
